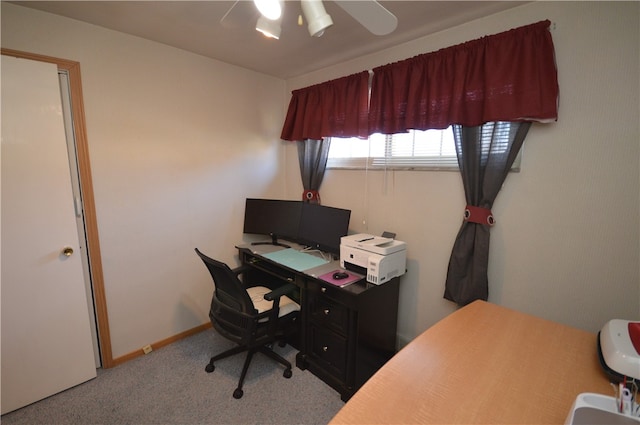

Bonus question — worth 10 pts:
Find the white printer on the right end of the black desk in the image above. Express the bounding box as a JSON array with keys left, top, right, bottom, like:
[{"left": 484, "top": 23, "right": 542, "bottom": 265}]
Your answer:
[{"left": 340, "top": 233, "right": 407, "bottom": 285}]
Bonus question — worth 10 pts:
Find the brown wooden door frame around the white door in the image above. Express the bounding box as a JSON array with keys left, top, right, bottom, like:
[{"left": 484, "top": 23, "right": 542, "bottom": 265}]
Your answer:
[{"left": 0, "top": 48, "right": 115, "bottom": 368}]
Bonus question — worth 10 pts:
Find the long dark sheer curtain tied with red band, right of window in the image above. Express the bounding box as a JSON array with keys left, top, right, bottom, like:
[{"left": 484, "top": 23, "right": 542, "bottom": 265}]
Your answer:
[{"left": 444, "top": 122, "right": 531, "bottom": 305}]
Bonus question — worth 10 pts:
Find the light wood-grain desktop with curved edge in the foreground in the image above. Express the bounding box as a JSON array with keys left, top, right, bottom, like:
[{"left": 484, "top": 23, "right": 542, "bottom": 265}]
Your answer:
[{"left": 331, "top": 301, "right": 613, "bottom": 424}]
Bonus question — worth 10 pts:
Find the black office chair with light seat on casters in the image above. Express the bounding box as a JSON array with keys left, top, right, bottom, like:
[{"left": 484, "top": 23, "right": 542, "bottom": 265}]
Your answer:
[{"left": 196, "top": 248, "right": 300, "bottom": 399}]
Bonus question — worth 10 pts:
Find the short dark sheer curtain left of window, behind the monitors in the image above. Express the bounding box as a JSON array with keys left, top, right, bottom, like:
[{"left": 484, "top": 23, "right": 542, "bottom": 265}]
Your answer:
[{"left": 297, "top": 138, "right": 331, "bottom": 204}]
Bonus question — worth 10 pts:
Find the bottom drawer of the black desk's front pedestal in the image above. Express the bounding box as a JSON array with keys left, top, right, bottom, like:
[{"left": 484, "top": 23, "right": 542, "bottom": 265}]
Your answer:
[{"left": 309, "top": 326, "right": 347, "bottom": 380}]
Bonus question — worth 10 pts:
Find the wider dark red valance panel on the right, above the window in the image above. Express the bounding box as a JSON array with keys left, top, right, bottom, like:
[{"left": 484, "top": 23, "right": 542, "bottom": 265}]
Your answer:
[{"left": 369, "top": 20, "right": 558, "bottom": 134}]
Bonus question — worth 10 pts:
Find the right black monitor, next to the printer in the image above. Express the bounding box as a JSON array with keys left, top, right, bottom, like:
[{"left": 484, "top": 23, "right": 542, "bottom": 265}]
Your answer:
[{"left": 298, "top": 203, "right": 351, "bottom": 255}]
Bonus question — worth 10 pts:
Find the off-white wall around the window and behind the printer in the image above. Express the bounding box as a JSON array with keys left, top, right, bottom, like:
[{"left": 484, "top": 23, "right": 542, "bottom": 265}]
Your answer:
[{"left": 285, "top": 2, "right": 640, "bottom": 342}]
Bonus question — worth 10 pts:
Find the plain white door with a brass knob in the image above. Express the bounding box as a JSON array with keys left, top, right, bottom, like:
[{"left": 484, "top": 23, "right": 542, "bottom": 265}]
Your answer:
[{"left": 0, "top": 55, "right": 96, "bottom": 413}]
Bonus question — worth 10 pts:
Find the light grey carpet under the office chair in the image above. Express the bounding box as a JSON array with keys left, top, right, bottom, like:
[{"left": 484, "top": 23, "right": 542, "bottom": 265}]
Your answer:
[{"left": 1, "top": 329, "right": 344, "bottom": 425}]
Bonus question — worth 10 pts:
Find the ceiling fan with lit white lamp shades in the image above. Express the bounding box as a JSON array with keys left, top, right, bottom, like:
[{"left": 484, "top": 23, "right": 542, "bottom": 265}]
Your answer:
[{"left": 220, "top": 0, "right": 398, "bottom": 39}]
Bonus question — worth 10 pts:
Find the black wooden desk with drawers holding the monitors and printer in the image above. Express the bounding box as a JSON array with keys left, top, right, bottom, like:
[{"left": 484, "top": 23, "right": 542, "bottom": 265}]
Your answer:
[{"left": 238, "top": 244, "right": 399, "bottom": 401}]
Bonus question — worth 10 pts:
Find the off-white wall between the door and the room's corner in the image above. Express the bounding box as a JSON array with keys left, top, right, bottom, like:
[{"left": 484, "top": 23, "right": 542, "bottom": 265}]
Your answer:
[{"left": 2, "top": 2, "right": 285, "bottom": 358}]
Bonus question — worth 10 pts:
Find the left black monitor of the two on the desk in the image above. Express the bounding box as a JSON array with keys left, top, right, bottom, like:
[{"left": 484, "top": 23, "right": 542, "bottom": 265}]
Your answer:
[{"left": 244, "top": 198, "right": 302, "bottom": 242}]
